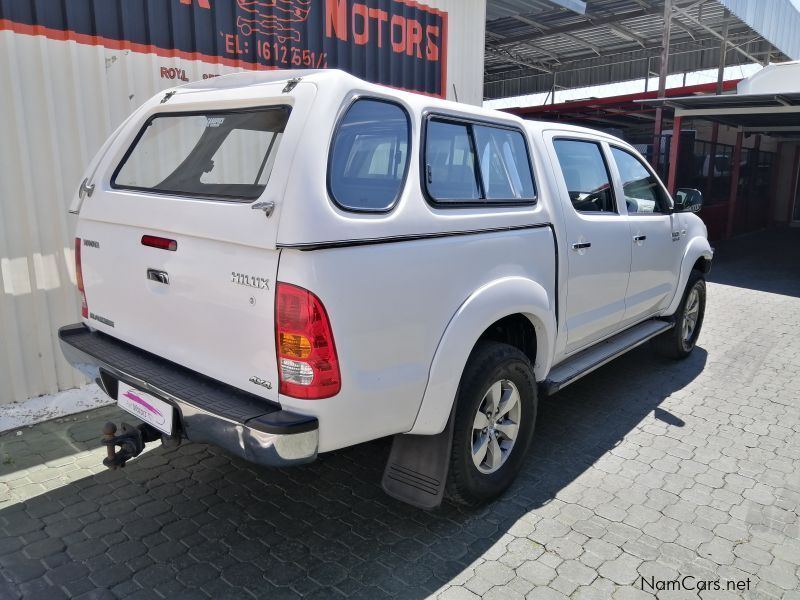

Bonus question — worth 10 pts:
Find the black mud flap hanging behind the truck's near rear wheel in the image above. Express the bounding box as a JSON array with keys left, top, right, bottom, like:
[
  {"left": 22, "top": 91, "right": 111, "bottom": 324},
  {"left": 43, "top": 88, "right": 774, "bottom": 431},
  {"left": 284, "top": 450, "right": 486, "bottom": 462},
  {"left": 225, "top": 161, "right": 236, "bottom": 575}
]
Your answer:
[{"left": 381, "top": 406, "right": 456, "bottom": 510}]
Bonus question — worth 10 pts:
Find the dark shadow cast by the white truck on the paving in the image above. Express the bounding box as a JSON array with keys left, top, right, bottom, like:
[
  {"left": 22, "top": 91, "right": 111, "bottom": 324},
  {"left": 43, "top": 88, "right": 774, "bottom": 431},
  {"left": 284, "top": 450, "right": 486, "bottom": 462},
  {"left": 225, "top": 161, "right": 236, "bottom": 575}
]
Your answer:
[{"left": 0, "top": 347, "right": 707, "bottom": 599}]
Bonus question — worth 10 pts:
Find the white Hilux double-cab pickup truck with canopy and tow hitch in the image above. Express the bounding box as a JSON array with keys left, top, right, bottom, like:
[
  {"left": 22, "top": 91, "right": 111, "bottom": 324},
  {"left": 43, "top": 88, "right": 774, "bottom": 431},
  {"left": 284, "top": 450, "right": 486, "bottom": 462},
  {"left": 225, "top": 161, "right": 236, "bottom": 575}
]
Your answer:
[{"left": 59, "top": 71, "right": 712, "bottom": 508}]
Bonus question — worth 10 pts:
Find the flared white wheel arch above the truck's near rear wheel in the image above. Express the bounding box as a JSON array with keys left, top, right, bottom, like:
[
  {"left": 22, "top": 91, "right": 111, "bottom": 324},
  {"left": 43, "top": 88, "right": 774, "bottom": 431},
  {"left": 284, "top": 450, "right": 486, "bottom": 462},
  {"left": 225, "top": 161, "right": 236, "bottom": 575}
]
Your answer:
[{"left": 408, "top": 277, "right": 556, "bottom": 435}]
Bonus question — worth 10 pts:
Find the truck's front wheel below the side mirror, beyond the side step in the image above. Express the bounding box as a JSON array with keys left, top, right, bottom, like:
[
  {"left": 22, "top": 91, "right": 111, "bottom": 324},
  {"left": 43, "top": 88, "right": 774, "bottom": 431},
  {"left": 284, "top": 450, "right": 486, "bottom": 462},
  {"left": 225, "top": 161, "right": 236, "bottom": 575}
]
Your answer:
[{"left": 653, "top": 271, "right": 706, "bottom": 359}]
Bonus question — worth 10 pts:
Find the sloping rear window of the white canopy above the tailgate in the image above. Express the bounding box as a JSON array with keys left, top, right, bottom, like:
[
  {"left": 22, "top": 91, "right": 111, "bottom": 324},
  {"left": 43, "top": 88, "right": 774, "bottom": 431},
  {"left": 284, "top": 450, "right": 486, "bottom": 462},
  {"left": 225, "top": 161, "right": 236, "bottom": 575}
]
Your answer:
[{"left": 111, "top": 107, "right": 289, "bottom": 202}]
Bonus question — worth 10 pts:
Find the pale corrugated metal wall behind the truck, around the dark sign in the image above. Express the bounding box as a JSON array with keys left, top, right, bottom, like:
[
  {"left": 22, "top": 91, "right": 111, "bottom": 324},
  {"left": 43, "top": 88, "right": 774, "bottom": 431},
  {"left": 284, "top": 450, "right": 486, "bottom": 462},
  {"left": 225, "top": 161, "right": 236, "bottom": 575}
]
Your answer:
[{"left": 0, "top": 0, "right": 486, "bottom": 404}]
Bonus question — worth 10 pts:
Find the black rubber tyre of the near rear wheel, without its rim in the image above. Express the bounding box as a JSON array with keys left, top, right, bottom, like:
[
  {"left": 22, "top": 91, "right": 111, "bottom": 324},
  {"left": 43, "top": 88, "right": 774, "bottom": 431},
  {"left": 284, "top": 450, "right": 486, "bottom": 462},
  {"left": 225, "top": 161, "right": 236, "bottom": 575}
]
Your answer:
[{"left": 446, "top": 342, "right": 537, "bottom": 506}]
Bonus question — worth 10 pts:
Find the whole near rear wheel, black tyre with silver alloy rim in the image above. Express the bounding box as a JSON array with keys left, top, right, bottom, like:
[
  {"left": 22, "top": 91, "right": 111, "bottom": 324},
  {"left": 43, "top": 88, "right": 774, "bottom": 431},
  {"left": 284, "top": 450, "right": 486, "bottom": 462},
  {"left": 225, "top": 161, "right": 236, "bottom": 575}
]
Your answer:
[{"left": 447, "top": 342, "right": 537, "bottom": 506}]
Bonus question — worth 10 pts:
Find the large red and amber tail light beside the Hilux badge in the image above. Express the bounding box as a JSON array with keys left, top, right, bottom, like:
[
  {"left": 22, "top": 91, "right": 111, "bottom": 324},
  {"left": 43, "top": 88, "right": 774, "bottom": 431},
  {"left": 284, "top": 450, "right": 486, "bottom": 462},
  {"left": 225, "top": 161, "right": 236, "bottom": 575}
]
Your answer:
[{"left": 275, "top": 282, "right": 342, "bottom": 400}]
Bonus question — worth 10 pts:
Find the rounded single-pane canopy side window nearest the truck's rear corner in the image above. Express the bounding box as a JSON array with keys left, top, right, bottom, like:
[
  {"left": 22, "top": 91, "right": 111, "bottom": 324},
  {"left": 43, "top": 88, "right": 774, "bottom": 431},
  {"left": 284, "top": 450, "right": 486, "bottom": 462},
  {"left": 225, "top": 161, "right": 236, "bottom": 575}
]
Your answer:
[{"left": 328, "top": 99, "right": 410, "bottom": 212}]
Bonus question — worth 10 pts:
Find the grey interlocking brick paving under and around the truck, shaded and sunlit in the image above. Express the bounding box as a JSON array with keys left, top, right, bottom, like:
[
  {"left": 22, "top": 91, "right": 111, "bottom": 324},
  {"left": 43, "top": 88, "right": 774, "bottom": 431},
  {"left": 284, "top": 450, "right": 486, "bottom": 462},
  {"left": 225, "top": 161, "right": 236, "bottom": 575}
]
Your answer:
[{"left": 0, "top": 231, "right": 800, "bottom": 600}]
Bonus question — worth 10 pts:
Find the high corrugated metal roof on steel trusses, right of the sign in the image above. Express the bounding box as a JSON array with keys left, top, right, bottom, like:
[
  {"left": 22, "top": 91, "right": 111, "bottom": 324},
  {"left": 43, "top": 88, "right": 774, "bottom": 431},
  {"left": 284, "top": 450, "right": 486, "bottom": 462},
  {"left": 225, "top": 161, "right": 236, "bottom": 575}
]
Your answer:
[{"left": 484, "top": 0, "right": 800, "bottom": 98}]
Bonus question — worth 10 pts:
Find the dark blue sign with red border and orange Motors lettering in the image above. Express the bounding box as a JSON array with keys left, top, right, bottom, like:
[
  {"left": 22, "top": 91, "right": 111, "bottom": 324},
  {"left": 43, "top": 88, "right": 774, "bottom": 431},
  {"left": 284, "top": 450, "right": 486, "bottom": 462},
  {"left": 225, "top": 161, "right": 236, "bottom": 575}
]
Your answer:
[{"left": 0, "top": 0, "right": 447, "bottom": 97}]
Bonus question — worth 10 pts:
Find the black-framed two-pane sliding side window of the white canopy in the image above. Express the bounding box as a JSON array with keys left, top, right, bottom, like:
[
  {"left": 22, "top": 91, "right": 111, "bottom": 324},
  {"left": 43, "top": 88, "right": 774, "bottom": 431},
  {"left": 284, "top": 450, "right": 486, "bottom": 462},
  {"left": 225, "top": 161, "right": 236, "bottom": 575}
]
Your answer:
[{"left": 423, "top": 117, "right": 536, "bottom": 206}]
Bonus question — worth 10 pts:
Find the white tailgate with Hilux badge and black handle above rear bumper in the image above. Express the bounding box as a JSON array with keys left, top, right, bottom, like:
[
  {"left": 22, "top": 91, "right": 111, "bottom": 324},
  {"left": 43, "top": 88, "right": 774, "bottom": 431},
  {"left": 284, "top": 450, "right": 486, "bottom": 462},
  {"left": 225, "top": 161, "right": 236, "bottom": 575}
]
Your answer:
[{"left": 78, "top": 220, "right": 279, "bottom": 399}]
